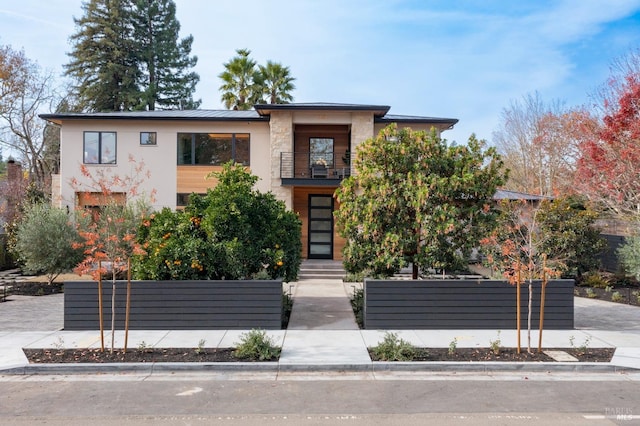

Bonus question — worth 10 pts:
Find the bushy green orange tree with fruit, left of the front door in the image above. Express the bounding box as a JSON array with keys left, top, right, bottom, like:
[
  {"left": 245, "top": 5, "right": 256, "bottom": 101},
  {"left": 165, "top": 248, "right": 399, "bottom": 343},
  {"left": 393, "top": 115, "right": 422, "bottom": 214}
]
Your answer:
[{"left": 133, "top": 163, "right": 302, "bottom": 281}]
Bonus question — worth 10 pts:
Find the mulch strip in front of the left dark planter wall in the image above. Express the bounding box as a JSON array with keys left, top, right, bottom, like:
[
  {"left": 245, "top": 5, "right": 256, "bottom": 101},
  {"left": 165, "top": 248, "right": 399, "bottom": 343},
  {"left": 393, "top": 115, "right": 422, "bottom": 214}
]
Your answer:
[{"left": 23, "top": 348, "right": 278, "bottom": 364}]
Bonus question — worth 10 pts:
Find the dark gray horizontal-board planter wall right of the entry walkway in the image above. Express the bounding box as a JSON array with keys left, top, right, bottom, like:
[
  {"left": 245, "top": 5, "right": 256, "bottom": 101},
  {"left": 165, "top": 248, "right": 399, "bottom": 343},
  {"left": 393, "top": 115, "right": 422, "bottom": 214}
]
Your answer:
[{"left": 364, "top": 279, "right": 574, "bottom": 330}]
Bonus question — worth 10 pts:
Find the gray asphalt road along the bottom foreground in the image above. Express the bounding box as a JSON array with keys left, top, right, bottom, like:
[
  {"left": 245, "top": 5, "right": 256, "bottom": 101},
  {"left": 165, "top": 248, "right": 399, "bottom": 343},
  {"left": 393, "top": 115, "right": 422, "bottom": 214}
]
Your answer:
[{"left": 0, "top": 374, "right": 640, "bottom": 426}]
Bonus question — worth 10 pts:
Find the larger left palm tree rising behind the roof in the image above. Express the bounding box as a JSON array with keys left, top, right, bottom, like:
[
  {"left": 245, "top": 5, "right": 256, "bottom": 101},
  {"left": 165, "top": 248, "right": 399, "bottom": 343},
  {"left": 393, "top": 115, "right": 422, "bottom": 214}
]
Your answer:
[{"left": 218, "top": 49, "right": 261, "bottom": 110}]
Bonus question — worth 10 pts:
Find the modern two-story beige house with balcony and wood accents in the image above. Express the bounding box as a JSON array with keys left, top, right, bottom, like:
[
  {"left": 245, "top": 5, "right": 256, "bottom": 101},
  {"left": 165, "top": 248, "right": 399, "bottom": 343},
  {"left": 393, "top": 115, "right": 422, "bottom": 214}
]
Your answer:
[{"left": 40, "top": 103, "right": 458, "bottom": 259}]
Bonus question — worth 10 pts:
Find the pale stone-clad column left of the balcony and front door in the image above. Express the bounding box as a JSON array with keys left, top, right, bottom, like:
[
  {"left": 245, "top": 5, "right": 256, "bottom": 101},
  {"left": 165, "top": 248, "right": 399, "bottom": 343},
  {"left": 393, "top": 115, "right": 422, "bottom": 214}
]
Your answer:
[{"left": 269, "top": 111, "right": 293, "bottom": 209}]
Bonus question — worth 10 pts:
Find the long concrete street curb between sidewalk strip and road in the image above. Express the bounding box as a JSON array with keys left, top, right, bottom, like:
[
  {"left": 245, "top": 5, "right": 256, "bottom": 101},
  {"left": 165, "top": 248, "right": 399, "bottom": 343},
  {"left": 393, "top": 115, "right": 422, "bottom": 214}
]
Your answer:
[{"left": 0, "top": 361, "right": 640, "bottom": 375}]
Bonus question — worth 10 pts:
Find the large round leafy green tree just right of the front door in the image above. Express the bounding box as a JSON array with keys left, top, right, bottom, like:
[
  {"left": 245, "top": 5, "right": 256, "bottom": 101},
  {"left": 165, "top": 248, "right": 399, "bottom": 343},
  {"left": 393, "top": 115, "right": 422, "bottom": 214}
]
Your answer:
[{"left": 336, "top": 124, "right": 506, "bottom": 278}]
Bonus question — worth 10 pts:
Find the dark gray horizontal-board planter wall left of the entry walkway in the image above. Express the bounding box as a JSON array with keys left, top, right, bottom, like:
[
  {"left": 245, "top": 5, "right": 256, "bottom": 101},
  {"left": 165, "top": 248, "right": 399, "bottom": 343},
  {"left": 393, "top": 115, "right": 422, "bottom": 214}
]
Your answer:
[{"left": 64, "top": 280, "right": 282, "bottom": 330}]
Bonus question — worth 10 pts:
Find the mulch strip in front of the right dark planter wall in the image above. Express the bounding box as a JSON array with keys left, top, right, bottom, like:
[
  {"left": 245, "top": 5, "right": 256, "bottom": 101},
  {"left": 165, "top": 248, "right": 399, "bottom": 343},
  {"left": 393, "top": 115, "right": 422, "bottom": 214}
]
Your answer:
[{"left": 369, "top": 347, "right": 615, "bottom": 362}]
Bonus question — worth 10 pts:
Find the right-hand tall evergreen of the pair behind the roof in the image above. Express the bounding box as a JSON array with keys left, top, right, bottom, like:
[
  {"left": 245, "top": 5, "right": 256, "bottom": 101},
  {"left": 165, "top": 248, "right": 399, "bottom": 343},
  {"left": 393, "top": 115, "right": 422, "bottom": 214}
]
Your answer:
[{"left": 132, "top": 0, "right": 200, "bottom": 111}]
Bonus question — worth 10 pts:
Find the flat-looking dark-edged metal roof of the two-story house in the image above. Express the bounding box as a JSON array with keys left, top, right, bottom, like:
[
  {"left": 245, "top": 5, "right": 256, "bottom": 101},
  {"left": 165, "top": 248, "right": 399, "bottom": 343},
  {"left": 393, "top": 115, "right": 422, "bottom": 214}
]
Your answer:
[{"left": 40, "top": 102, "right": 458, "bottom": 126}]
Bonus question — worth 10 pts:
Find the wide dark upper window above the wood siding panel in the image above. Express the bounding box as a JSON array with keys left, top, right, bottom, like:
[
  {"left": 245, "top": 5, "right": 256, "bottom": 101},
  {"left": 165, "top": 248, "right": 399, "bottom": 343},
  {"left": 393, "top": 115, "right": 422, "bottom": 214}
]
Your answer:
[{"left": 178, "top": 133, "right": 249, "bottom": 166}]
